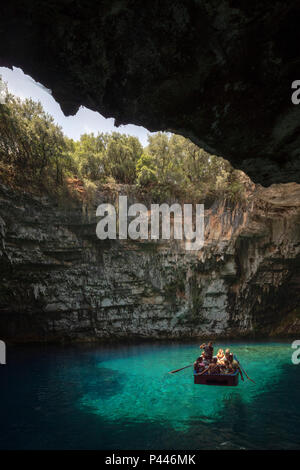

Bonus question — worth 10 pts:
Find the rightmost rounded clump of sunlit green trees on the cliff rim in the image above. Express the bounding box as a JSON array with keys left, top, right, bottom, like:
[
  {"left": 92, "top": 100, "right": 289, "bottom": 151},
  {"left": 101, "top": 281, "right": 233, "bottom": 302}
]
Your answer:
[{"left": 137, "top": 132, "right": 243, "bottom": 200}]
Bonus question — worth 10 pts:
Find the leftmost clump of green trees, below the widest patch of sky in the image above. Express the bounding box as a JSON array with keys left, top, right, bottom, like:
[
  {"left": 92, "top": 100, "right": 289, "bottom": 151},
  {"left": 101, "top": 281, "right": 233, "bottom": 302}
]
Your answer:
[{"left": 0, "top": 79, "right": 72, "bottom": 183}]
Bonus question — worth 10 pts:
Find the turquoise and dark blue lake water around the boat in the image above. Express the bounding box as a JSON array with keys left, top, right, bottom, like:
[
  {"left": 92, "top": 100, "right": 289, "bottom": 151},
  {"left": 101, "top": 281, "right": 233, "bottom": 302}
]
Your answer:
[{"left": 0, "top": 342, "right": 300, "bottom": 450}]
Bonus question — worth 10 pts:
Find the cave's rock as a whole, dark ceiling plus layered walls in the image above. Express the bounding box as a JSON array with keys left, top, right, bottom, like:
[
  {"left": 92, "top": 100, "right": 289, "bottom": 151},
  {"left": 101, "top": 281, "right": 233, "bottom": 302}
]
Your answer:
[{"left": 0, "top": 0, "right": 300, "bottom": 341}]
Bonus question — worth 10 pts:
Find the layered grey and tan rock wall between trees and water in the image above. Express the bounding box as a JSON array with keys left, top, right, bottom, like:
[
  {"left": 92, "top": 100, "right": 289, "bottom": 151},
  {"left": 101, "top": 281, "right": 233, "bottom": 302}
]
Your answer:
[{"left": 0, "top": 180, "right": 300, "bottom": 341}]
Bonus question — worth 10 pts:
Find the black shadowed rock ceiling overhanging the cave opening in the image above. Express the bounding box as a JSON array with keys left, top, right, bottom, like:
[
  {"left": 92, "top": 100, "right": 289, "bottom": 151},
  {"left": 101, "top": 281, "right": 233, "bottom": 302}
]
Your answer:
[{"left": 0, "top": 0, "right": 300, "bottom": 186}]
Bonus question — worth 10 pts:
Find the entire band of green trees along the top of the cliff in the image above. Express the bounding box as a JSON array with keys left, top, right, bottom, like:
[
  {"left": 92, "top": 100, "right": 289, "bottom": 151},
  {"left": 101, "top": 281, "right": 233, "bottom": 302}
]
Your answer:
[{"left": 0, "top": 78, "right": 243, "bottom": 202}]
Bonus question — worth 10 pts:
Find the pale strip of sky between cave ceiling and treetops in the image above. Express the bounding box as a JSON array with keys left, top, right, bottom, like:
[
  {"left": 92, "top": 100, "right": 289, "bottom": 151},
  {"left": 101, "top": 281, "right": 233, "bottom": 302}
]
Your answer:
[{"left": 0, "top": 67, "right": 150, "bottom": 146}]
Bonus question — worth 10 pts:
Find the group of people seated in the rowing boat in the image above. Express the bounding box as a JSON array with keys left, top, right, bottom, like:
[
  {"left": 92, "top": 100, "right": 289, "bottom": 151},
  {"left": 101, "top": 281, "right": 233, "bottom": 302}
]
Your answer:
[{"left": 194, "top": 341, "right": 239, "bottom": 375}]
